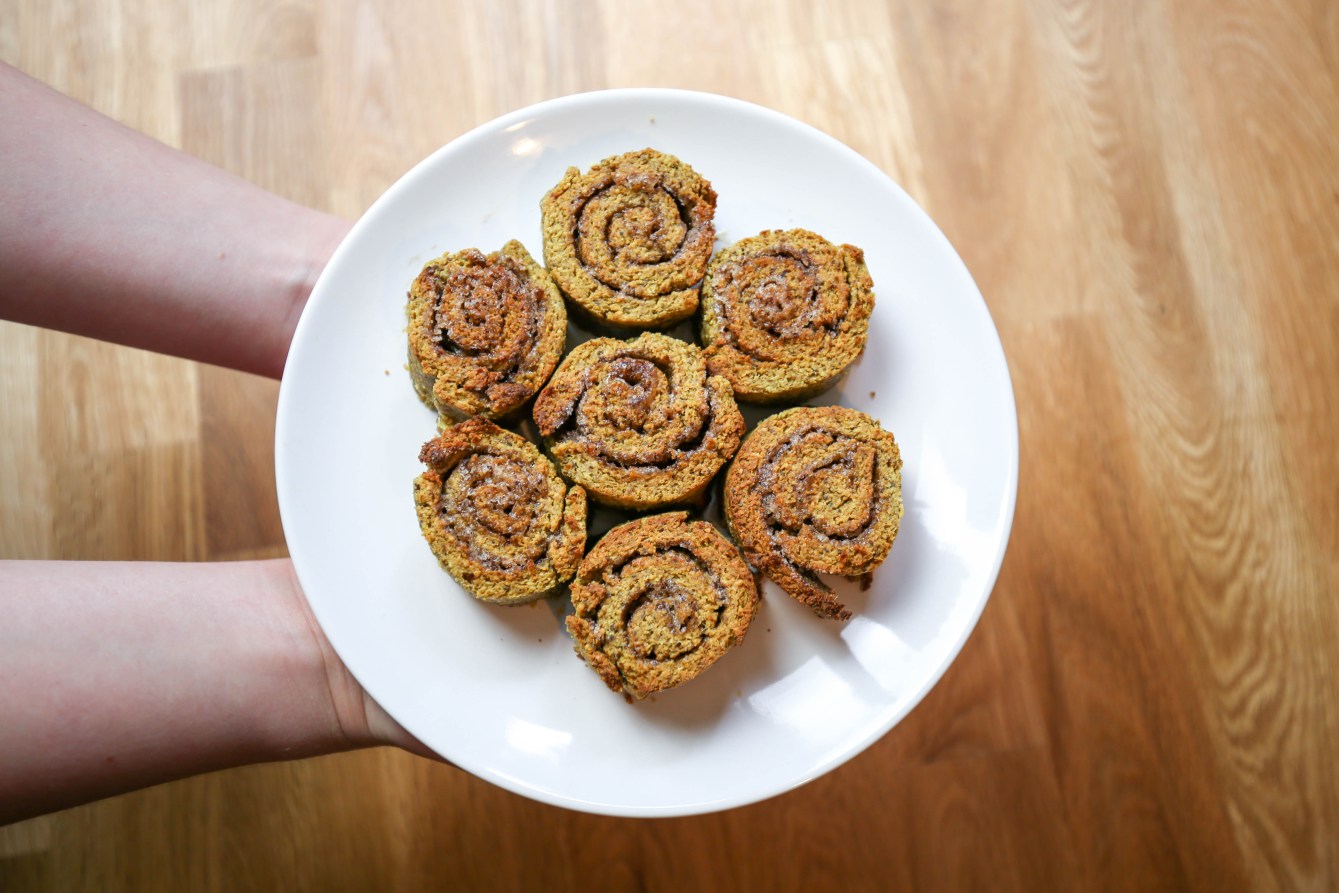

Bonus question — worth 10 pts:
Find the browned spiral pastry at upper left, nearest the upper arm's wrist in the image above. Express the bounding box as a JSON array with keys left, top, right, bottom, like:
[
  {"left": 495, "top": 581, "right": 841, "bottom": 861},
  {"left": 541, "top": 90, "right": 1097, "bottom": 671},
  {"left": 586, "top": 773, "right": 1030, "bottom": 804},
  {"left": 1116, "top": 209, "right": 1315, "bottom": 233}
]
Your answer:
[{"left": 408, "top": 240, "right": 568, "bottom": 419}]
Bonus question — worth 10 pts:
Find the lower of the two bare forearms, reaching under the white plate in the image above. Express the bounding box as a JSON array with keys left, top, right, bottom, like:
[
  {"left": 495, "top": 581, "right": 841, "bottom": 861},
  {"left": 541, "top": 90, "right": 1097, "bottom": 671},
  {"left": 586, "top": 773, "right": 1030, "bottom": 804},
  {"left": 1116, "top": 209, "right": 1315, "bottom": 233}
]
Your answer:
[{"left": 0, "top": 561, "right": 377, "bottom": 825}]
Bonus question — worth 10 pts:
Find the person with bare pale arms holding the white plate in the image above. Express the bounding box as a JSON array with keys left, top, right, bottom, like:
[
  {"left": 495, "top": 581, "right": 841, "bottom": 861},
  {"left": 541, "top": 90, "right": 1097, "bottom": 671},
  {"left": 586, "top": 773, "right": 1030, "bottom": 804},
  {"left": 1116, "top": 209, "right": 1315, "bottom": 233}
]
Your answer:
[{"left": 0, "top": 64, "right": 432, "bottom": 825}]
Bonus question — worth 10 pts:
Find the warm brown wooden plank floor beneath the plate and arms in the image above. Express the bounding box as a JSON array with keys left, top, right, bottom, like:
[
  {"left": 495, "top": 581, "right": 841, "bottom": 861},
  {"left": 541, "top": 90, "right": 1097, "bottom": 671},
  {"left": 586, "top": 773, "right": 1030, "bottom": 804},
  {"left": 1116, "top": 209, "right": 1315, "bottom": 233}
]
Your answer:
[{"left": 0, "top": 0, "right": 1339, "bottom": 893}]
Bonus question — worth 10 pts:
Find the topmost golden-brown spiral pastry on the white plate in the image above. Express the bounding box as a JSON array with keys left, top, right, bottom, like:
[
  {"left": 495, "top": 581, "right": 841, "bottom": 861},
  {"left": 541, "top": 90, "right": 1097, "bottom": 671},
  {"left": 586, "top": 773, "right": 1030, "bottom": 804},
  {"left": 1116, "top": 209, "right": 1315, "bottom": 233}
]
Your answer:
[{"left": 540, "top": 149, "right": 716, "bottom": 332}]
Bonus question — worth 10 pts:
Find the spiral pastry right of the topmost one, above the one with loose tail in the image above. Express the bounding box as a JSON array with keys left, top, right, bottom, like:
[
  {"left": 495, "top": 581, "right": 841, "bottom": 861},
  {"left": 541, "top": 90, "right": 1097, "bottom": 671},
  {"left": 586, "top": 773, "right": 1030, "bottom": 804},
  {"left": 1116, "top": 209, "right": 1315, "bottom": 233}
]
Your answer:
[{"left": 700, "top": 229, "right": 874, "bottom": 403}]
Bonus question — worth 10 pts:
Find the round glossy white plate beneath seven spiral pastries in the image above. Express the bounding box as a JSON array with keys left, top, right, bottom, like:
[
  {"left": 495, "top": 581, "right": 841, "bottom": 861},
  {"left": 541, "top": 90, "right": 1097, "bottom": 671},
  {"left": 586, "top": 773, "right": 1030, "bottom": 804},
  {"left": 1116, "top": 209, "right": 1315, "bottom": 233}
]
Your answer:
[{"left": 274, "top": 90, "right": 1018, "bottom": 815}]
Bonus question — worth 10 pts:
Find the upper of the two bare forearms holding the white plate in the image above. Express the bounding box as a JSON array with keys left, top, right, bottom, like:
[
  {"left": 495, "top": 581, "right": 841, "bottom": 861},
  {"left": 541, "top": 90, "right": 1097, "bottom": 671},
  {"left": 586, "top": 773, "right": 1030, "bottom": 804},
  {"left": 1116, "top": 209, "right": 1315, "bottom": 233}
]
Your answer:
[{"left": 0, "top": 64, "right": 348, "bottom": 376}]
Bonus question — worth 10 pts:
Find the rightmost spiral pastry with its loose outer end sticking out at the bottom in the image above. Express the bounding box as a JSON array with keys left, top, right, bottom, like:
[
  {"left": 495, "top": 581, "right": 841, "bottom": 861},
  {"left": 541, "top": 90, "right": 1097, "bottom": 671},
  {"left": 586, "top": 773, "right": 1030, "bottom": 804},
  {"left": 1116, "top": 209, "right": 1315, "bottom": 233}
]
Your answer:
[{"left": 724, "top": 406, "right": 902, "bottom": 620}]
